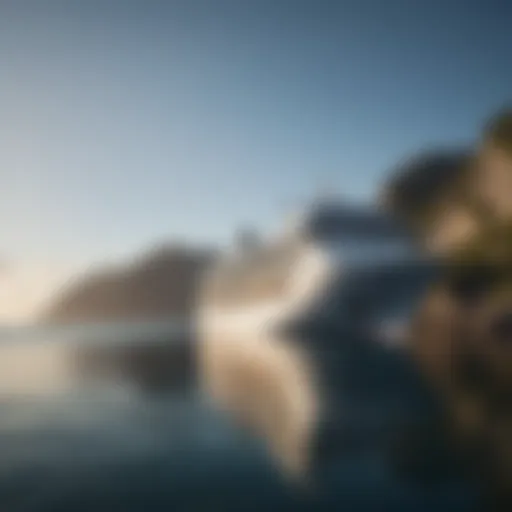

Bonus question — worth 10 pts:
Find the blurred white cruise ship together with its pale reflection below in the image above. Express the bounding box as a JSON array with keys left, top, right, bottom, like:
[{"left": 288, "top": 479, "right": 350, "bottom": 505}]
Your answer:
[{"left": 198, "top": 200, "right": 438, "bottom": 477}]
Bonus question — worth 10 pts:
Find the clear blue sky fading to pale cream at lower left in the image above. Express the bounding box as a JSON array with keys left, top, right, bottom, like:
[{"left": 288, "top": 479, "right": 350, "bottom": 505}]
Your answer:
[{"left": 0, "top": 0, "right": 512, "bottom": 321}]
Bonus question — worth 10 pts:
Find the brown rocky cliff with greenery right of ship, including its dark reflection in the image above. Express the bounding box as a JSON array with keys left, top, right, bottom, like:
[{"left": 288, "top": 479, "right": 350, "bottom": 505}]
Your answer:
[{"left": 382, "top": 111, "right": 512, "bottom": 510}]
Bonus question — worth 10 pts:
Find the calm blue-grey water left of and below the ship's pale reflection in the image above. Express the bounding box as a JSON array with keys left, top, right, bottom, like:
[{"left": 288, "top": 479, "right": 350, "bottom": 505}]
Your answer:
[{"left": 0, "top": 324, "right": 473, "bottom": 512}]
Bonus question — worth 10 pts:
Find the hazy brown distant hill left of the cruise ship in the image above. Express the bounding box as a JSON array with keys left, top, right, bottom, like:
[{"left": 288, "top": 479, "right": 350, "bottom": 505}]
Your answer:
[{"left": 41, "top": 245, "right": 214, "bottom": 323}]
